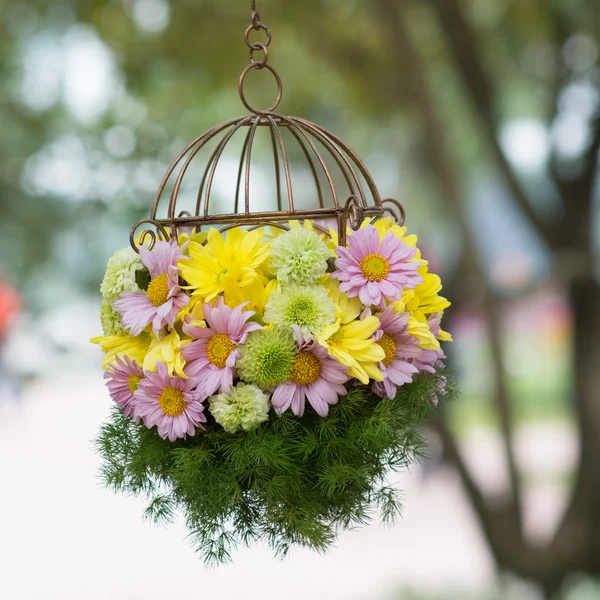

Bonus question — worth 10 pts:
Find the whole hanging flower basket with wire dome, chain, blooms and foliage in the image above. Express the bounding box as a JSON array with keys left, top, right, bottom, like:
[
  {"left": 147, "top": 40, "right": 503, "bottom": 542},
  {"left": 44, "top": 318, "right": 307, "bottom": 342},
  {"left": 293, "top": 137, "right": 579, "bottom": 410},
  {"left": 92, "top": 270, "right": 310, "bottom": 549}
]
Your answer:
[{"left": 93, "top": 1, "right": 450, "bottom": 562}]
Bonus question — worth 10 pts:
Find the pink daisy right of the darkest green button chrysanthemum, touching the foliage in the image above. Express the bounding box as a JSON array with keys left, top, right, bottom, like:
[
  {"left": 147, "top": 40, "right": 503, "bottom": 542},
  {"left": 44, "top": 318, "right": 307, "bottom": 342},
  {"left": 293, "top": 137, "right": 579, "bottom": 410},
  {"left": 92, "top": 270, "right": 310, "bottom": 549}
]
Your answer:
[{"left": 271, "top": 325, "right": 349, "bottom": 417}]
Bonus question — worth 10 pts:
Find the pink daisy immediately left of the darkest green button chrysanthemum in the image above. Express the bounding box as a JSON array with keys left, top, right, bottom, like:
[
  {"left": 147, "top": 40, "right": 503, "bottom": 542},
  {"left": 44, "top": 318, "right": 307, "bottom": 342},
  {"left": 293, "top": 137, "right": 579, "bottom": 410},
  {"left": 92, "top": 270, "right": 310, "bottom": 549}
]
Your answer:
[{"left": 181, "top": 297, "right": 262, "bottom": 398}]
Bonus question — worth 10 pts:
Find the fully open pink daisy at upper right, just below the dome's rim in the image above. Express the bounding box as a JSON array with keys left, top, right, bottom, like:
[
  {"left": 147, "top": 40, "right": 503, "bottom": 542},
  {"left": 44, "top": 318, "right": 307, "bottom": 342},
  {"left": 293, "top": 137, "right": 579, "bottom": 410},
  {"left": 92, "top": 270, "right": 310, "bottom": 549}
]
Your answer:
[{"left": 331, "top": 225, "right": 423, "bottom": 310}]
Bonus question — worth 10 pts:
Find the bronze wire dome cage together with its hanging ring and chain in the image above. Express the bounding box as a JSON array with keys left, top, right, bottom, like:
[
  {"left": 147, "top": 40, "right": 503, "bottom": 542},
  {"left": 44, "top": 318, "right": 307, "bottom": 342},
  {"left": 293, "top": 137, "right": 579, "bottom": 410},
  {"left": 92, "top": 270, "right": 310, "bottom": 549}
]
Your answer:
[{"left": 130, "top": 2, "right": 405, "bottom": 251}]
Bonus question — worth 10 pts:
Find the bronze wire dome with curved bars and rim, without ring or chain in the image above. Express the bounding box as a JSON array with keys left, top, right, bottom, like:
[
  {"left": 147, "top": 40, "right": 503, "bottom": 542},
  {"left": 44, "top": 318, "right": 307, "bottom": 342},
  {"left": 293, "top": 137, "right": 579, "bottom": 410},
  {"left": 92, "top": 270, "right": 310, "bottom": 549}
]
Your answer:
[{"left": 137, "top": 112, "right": 394, "bottom": 250}]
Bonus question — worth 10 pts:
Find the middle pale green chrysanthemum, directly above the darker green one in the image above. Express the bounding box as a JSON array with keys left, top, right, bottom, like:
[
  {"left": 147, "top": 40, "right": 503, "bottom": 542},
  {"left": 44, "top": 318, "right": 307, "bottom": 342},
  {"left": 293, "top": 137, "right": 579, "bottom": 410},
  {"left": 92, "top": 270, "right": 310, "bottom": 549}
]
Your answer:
[{"left": 264, "top": 285, "right": 335, "bottom": 335}]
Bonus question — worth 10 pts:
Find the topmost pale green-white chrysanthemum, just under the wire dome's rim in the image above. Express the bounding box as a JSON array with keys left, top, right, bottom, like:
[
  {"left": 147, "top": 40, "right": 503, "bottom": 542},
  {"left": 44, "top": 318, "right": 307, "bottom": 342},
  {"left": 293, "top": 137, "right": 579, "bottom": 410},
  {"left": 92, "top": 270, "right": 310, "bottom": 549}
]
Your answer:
[{"left": 271, "top": 229, "right": 331, "bottom": 285}]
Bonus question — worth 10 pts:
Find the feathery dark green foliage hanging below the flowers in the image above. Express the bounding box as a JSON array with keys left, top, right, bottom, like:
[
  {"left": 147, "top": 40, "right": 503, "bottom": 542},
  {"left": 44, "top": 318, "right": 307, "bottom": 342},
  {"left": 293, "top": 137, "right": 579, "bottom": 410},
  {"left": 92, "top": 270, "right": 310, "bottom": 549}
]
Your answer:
[{"left": 96, "top": 374, "right": 452, "bottom": 564}]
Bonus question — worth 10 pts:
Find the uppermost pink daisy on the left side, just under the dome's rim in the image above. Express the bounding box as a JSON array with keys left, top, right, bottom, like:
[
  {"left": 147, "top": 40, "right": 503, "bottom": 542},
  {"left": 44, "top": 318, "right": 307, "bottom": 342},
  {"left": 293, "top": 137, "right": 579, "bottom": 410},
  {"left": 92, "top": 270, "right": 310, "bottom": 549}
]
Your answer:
[{"left": 113, "top": 240, "right": 190, "bottom": 336}]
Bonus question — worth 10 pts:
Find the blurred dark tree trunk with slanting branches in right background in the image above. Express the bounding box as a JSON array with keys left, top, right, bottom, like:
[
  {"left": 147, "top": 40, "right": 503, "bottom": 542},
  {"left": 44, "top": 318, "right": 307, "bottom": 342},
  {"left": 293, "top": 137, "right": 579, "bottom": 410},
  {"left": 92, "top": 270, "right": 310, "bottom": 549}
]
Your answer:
[{"left": 372, "top": 0, "right": 600, "bottom": 596}]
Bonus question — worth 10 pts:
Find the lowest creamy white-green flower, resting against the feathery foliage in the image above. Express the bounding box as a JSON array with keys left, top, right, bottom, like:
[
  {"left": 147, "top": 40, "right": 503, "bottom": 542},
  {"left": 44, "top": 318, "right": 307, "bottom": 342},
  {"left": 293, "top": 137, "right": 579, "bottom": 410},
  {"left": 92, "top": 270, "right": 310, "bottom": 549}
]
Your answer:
[{"left": 208, "top": 383, "right": 271, "bottom": 433}]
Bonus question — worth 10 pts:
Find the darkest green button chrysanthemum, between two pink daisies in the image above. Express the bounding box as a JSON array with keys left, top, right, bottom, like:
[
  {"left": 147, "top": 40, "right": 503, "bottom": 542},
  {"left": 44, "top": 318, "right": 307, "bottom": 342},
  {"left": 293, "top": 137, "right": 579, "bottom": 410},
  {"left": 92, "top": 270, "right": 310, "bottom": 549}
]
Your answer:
[{"left": 236, "top": 327, "right": 296, "bottom": 389}]
